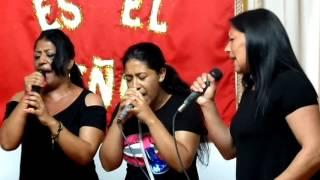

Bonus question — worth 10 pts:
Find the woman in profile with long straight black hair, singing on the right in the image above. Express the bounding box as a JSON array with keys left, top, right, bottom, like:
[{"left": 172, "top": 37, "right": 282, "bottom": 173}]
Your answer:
[{"left": 191, "top": 9, "right": 320, "bottom": 180}]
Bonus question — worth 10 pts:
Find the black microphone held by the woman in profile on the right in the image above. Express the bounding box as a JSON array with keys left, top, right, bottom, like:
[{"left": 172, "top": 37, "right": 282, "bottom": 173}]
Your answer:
[{"left": 178, "top": 68, "right": 223, "bottom": 112}]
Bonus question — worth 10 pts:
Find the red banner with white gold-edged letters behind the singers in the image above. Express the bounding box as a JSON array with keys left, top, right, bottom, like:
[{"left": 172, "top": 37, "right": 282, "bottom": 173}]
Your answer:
[{"left": 0, "top": 0, "right": 236, "bottom": 124}]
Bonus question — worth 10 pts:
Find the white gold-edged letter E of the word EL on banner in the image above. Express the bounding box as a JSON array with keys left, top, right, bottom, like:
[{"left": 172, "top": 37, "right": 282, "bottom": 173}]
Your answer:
[{"left": 121, "top": 0, "right": 143, "bottom": 28}]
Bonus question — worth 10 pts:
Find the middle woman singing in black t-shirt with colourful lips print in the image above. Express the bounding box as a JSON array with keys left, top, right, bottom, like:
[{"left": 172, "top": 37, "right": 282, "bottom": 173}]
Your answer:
[{"left": 100, "top": 42, "right": 206, "bottom": 180}]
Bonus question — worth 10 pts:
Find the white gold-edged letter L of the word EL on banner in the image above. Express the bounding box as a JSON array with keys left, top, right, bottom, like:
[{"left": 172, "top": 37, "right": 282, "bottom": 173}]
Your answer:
[{"left": 149, "top": 0, "right": 168, "bottom": 33}]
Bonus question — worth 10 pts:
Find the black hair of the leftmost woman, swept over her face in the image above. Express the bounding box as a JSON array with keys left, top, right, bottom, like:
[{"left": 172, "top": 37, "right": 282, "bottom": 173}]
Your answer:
[{"left": 34, "top": 29, "right": 84, "bottom": 87}]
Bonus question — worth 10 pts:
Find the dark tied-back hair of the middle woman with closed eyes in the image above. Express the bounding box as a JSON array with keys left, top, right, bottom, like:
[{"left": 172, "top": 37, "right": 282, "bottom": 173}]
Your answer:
[{"left": 122, "top": 42, "right": 209, "bottom": 165}]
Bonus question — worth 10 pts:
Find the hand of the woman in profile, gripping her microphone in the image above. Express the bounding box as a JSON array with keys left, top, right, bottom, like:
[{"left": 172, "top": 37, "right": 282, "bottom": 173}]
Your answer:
[{"left": 190, "top": 73, "right": 216, "bottom": 105}]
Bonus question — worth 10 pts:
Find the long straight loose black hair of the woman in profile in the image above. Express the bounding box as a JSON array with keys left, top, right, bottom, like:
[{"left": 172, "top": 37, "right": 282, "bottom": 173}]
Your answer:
[{"left": 231, "top": 9, "right": 306, "bottom": 113}]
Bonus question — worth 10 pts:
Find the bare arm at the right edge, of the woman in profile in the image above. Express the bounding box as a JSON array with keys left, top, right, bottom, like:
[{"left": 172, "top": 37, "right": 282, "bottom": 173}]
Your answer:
[{"left": 276, "top": 105, "right": 320, "bottom": 180}]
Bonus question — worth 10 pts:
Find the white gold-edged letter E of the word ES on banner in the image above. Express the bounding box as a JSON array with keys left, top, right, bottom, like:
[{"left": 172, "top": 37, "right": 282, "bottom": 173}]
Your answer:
[{"left": 33, "top": 0, "right": 61, "bottom": 30}]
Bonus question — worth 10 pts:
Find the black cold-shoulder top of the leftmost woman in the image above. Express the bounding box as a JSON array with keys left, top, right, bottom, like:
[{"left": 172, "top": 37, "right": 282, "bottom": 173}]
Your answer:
[{"left": 5, "top": 90, "right": 106, "bottom": 180}]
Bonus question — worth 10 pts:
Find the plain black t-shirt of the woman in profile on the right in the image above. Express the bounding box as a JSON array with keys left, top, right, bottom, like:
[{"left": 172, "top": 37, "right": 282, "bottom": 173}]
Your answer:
[{"left": 231, "top": 71, "right": 320, "bottom": 180}]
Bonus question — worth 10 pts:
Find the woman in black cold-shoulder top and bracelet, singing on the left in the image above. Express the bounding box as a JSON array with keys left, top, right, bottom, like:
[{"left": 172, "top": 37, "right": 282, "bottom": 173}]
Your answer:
[{"left": 0, "top": 29, "right": 106, "bottom": 180}]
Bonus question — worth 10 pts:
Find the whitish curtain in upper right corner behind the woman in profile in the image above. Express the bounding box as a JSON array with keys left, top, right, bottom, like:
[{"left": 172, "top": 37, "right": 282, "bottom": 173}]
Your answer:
[{"left": 262, "top": 0, "right": 320, "bottom": 94}]
